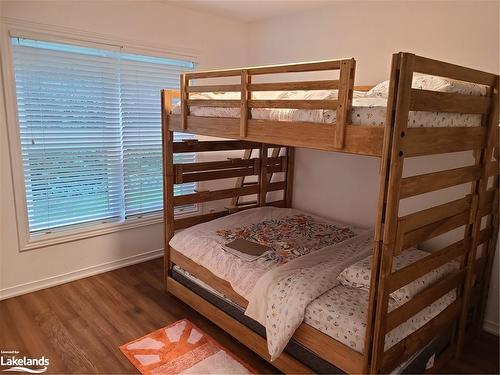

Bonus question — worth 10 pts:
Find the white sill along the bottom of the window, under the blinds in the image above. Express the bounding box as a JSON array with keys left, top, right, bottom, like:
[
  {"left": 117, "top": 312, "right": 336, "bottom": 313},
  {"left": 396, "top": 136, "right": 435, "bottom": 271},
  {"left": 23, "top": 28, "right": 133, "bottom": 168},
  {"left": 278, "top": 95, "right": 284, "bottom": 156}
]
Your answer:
[{"left": 20, "top": 207, "right": 200, "bottom": 252}]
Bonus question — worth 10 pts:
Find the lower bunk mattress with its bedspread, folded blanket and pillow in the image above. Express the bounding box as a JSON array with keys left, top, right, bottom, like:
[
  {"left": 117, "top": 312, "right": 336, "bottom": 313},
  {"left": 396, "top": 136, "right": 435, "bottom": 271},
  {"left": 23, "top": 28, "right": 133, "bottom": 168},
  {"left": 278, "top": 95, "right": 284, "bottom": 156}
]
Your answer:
[{"left": 170, "top": 207, "right": 458, "bottom": 358}]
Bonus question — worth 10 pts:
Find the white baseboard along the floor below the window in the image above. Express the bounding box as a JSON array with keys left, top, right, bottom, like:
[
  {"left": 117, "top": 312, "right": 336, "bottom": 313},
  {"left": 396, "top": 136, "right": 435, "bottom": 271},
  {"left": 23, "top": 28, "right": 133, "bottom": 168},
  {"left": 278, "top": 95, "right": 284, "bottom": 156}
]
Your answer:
[{"left": 0, "top": 249, "right": 163, "bottom": 300}]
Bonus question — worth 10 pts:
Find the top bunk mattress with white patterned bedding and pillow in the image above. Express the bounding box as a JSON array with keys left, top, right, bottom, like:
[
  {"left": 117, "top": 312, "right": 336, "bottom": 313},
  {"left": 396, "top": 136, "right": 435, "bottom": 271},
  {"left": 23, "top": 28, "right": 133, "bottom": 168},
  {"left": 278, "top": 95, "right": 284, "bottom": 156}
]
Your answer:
[{"left": 172, "top": 75, "right": 487, "bottom": 128}]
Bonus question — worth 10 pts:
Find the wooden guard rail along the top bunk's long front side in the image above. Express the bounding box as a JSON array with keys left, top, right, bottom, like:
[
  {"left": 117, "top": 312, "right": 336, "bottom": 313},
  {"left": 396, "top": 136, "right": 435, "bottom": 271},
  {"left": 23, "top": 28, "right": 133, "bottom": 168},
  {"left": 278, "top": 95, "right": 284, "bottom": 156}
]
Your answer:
[{"left": 176, "top": 58, "right": 356, "bottom": 149}]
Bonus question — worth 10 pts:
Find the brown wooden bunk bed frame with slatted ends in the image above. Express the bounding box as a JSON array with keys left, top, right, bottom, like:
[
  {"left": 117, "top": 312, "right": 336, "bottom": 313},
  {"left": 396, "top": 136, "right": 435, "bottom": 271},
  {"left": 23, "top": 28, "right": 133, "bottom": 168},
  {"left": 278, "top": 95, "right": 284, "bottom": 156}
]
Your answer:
[{"left": 162, "top": 53, "right": 499, "bottom": 373}]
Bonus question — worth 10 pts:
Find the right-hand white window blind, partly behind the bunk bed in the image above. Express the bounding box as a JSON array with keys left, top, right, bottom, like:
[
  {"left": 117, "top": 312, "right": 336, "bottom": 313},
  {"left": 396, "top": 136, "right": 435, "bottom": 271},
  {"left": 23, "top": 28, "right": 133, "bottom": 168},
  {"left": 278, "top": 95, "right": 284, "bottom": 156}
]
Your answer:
[{"left": 120, "top": 54, "right": 196, "bottom": 216}]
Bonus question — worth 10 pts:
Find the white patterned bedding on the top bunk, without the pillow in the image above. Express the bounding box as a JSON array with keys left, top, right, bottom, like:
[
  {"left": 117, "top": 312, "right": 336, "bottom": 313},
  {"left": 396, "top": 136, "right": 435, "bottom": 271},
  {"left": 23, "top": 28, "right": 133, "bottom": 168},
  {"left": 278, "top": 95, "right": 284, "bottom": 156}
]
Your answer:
[{"left": 172, "top": 91, "right": 481, "bottom": 128}]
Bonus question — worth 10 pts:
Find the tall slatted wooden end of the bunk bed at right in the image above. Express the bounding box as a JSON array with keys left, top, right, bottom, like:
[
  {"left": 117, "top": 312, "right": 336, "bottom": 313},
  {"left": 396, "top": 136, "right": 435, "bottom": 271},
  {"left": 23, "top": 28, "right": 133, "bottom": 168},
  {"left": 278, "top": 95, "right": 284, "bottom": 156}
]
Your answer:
[{"left": 365, "top": 53, "right": 499, "bottom": 373}]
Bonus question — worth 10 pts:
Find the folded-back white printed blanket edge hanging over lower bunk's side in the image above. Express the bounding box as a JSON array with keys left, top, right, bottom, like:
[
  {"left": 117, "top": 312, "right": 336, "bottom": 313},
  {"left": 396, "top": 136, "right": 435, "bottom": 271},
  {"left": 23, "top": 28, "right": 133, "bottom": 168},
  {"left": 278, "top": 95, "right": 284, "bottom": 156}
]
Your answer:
[{"left": 245, "top": 232, "right": 373, "bottom": 360}]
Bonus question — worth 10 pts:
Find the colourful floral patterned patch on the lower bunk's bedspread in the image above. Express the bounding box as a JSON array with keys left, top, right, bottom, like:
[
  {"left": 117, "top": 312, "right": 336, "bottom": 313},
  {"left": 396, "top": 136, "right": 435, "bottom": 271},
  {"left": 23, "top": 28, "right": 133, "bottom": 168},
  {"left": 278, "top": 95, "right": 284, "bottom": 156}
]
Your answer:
[{"left": 217, "top": 214, "right": 356, "bottom": 264}]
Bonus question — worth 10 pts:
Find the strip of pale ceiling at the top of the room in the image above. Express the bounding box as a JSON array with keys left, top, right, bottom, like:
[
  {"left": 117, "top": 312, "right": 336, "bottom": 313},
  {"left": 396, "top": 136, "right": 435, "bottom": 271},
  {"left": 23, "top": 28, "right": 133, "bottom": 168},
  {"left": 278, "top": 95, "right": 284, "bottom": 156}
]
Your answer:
[{"left": 163, "top": 0, "right": 331, "bottom": 22}]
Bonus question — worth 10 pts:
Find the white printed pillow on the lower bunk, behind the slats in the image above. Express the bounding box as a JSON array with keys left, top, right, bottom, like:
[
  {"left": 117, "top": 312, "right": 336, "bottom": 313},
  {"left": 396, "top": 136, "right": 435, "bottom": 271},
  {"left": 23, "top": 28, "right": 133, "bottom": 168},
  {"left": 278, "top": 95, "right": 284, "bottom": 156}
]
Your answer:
[{"left": 338, "top": 249, "right": 459, "bottom": 304}]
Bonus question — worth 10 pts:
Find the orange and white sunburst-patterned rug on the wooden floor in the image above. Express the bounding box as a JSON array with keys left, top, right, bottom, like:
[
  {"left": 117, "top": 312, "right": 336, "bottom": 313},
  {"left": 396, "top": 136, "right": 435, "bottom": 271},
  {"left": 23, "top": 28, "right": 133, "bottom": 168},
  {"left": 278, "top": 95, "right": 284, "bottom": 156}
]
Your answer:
[{"left": 120, "top": 319, "right": 257, "bottom": 375}]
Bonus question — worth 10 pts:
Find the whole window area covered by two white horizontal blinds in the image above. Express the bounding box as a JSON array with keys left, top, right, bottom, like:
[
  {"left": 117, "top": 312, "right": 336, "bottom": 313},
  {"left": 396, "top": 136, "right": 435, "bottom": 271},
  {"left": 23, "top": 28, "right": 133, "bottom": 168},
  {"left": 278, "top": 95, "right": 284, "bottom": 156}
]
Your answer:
[{"left": 11, "top": 38, "right": 196, "bottom": 233}]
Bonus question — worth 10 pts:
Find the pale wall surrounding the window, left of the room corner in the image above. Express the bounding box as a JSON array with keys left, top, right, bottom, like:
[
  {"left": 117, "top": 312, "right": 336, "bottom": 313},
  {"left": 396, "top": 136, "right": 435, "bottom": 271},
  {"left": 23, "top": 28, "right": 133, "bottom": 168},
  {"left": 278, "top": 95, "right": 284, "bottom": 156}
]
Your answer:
[{"left": 0, "top": 0, "right": 248, "bottom": 296}]
